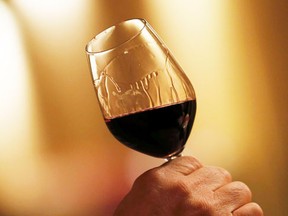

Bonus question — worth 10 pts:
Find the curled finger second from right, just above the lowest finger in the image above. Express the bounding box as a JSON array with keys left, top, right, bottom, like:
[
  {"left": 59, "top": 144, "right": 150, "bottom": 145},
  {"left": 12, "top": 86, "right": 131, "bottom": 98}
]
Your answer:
[{"left": 214, "top": 181, "right": 252, "bottom": 212}]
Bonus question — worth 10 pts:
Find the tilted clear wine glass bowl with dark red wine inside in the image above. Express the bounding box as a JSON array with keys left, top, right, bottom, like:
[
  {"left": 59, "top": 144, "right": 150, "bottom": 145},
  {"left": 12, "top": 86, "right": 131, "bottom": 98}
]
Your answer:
[{"left": 86, "top": 18, "right": 196, "bottom": 160}]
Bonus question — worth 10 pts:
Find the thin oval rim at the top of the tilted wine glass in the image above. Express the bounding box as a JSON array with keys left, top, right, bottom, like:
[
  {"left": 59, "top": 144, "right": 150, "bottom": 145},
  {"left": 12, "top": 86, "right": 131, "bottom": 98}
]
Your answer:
[{"left": 85, "top": 18, "right": 148, "bottom": 55}]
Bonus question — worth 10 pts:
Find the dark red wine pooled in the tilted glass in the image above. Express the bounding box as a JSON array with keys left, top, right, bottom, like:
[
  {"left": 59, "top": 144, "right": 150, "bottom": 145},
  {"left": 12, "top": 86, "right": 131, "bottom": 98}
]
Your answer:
[{"left": 105, "top": 100, "right": 196, "bottom": 158}]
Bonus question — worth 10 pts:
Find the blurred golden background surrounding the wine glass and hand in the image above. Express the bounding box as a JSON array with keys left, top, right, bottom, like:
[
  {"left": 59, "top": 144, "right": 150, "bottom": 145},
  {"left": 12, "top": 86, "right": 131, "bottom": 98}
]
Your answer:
[{"left": 0, "top": 0, "right": 288, "bottom": 216}]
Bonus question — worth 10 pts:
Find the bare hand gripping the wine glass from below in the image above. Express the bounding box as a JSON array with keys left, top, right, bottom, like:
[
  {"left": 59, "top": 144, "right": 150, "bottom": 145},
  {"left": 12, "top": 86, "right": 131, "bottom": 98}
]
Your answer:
[{"left": 114, "top": 156, "right": 263, "bottom": 216}]
